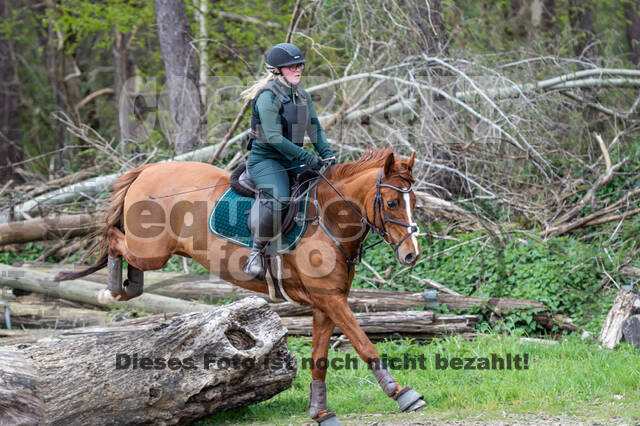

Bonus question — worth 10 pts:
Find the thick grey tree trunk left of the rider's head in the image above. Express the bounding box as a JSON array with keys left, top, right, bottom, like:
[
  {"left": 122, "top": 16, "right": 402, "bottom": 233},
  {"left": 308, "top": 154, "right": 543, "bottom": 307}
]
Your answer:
[{"left": 154, "top": 0, "right": 206, "bottom": 152}]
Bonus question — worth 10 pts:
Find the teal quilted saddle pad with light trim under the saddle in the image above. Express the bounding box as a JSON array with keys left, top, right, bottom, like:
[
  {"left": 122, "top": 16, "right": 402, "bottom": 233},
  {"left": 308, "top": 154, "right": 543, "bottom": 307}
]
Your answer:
[{"left": 208, "top": 184, "right": 311, "bottom": 254}]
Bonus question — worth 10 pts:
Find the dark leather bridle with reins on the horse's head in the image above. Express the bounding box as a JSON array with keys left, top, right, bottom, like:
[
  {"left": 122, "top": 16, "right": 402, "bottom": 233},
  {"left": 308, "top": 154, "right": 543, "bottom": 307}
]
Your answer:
[{"left": 309, "top": 168, "right": 418, "bottom": 269}]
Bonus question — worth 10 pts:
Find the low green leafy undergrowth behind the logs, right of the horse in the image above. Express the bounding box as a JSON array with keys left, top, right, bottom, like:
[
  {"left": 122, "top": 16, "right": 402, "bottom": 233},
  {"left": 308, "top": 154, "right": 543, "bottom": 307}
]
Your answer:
[{"left": 353, "top": 228, "right": 625, "bottom": 334}]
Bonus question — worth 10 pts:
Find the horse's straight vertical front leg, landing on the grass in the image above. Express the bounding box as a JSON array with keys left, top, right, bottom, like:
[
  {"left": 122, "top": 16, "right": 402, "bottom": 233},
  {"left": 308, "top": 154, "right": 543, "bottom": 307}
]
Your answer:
[{"left": 309, "top": 308, "right": 342, "bottom": 426}]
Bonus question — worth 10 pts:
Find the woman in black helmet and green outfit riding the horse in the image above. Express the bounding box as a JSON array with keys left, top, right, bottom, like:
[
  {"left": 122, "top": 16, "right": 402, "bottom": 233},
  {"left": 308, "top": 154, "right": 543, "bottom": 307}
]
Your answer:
[{"left": 242, "top": 43, "right": 335, "bottom": 279}]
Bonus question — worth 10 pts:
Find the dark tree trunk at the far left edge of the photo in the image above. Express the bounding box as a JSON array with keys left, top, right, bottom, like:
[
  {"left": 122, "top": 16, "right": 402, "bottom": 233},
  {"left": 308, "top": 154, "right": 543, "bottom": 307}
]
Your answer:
[{"left": 0, "top": 0, "right": 23, "bottom": 186}]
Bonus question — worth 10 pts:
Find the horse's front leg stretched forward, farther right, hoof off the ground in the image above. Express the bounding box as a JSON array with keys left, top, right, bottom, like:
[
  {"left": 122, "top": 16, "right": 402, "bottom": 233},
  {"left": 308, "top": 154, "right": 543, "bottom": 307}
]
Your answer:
[{"left": 314, "top": 296, "right": 425, "bottom": 412}]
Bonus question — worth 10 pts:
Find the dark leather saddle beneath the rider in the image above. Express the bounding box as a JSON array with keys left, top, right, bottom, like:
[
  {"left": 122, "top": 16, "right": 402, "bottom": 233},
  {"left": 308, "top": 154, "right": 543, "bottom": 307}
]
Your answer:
[{"left": 230, "top": 162, "right": 318, "bottom": 235}]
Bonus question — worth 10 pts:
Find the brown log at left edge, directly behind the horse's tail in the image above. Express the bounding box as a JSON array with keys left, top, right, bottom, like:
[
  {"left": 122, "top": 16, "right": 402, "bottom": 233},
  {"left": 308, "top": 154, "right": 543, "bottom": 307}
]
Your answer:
[{"left": 0, "top": 214, "right": 99, "bottom": 245}]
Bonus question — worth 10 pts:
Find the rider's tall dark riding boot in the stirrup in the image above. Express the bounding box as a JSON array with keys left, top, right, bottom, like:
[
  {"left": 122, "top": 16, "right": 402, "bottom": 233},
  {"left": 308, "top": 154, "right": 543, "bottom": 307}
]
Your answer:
[{"left": 242, "top": 199, "right": 280, "bottom": 281}]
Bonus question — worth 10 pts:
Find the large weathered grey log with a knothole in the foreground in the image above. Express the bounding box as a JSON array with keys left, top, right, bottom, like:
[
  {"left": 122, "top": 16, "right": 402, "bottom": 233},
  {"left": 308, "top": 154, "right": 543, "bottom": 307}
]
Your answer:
[{"left": 0, "top": 298, "right": 297, "bottom": 425}]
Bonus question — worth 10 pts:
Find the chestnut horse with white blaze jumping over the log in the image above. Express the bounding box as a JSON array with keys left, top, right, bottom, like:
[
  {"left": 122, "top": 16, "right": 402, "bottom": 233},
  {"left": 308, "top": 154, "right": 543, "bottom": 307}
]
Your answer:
[{"left": 56, "top": 148, "right": 425, "bottom": 426}]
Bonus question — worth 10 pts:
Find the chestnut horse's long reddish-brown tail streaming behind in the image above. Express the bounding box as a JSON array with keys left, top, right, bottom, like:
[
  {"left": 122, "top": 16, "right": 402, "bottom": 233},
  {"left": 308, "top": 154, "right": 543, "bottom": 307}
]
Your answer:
[{"left": 53, "top": 164, "right": 153, "bottom": 281}]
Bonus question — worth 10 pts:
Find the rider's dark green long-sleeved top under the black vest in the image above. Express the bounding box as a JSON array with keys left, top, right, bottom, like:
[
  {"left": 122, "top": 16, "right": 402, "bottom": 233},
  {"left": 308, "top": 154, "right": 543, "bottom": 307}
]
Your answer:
[{"left": 251, "top": 80, "right": 333, "bottom": 163}]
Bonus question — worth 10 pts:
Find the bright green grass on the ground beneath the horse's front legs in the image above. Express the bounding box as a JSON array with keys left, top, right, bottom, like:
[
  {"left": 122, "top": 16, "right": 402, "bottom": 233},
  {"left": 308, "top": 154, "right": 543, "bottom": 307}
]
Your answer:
[{"left": 199, "top": 336, "right": 640, "bottom": 425}]
